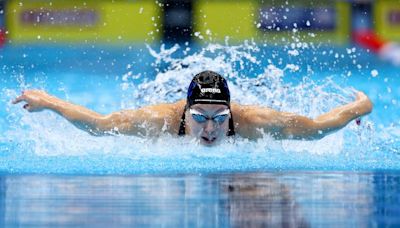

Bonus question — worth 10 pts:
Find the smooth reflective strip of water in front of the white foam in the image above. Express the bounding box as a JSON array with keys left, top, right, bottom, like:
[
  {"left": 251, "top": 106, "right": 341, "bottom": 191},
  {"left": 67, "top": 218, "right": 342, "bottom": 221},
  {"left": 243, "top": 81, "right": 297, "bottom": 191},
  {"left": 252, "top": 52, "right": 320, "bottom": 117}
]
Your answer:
[{"left": 0, "top": 172, "right": 400, "bottom": 227}]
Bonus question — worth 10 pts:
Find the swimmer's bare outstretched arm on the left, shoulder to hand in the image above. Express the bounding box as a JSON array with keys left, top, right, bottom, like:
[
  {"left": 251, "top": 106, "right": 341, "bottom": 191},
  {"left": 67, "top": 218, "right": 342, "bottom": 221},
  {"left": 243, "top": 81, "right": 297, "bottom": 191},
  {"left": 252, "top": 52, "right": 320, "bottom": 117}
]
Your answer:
[{"left": 13, "top": 90, "right": 180, "bottom": 136}]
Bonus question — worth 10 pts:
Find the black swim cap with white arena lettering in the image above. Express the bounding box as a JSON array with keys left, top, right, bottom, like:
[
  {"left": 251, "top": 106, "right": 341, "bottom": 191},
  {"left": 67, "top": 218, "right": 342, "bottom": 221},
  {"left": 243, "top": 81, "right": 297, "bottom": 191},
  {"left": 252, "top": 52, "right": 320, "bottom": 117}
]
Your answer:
[{"left": 187, "top": 71, "right": 231, "bottom": 107}]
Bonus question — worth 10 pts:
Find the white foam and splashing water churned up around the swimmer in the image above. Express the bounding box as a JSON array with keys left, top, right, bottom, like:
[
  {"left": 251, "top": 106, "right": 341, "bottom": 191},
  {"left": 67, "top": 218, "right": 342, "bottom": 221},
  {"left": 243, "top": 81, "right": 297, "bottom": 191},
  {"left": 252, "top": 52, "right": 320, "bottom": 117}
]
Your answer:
[{"left": 0, "top": 42, "right": 400, "bottom": 173}]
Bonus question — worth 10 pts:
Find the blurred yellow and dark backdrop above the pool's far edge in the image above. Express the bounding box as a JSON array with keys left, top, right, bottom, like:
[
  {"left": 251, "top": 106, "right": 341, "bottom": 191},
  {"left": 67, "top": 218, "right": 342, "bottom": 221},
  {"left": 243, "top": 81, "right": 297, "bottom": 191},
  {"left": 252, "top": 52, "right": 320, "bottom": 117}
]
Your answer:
[{"left": 0, "top": 0, "right": 400, "bottom": 51}]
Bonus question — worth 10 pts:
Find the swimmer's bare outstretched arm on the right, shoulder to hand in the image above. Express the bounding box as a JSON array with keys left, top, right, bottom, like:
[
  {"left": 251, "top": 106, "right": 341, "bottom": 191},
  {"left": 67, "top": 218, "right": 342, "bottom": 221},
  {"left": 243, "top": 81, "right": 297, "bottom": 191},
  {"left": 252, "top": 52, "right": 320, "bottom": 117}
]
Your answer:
[{"left": 238, "top": 92, "right": 372, "bottom": 140}]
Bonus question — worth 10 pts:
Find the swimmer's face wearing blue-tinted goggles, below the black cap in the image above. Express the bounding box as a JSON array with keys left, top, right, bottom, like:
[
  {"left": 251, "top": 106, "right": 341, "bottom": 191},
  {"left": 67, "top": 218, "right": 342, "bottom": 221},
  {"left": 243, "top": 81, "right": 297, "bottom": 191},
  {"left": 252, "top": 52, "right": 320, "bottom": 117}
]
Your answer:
[{"left": 186, "top": 104, "right": 231, "bottom": 146}]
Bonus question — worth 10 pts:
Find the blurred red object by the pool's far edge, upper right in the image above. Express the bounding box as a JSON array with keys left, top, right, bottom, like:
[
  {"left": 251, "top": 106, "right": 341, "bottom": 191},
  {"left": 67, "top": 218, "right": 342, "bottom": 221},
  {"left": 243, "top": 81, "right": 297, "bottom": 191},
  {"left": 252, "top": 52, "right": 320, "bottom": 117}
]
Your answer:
[{"left": 353, "top": 30, "right": 386, "bottom": 52}]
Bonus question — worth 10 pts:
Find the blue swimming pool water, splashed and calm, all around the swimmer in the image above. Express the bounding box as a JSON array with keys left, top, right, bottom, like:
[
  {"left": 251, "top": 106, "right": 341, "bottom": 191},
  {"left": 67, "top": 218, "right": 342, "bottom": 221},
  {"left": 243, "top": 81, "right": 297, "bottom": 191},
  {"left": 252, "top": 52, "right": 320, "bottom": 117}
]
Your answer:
[{"left": 0, "top": 42, "right": 400, "bottom": 227}]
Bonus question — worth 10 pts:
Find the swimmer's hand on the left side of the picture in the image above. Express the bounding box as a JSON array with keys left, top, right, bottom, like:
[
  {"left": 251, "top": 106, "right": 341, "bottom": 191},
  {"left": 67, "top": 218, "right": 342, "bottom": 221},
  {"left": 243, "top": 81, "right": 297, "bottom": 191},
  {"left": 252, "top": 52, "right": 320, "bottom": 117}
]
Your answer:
[{"left": 12, "top": 90, "right": 51, "bottom": 112}]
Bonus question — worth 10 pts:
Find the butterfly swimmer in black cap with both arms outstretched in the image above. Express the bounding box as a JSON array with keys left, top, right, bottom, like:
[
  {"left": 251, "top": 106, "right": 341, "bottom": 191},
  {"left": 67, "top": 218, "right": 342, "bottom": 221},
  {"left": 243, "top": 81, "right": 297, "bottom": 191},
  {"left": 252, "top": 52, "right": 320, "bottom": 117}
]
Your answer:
[{"left": 13, "top": 71, "right": 372, "bottom": 146}]
